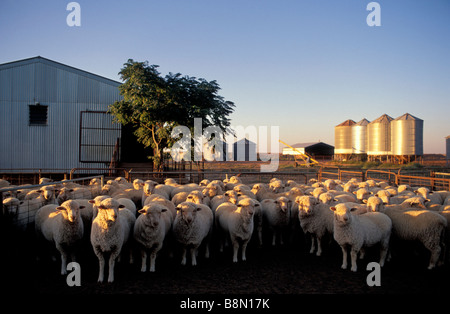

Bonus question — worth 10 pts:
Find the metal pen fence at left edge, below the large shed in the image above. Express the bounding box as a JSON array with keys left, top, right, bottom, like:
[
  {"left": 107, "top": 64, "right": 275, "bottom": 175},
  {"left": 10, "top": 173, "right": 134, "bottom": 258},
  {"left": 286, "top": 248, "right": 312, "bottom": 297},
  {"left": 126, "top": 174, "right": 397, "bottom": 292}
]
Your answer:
[{"left": 0, "top": 175, "right": 104, "bottom": 231}]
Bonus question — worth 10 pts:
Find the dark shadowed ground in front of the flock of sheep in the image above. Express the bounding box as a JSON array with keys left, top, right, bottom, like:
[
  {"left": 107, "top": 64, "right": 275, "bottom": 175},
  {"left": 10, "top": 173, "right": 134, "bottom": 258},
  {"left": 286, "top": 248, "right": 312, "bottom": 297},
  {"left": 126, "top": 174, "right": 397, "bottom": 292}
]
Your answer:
[{"left": 1, "top": 172, "right": 450, "bottom": 295}]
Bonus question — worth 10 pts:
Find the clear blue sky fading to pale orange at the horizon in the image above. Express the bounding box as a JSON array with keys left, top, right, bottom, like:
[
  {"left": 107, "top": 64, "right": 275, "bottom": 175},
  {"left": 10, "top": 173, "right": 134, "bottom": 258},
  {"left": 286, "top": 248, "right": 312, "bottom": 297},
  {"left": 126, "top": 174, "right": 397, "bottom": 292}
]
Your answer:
[{"left": 0, "top": 0, "right": 450, "bottom": 154}]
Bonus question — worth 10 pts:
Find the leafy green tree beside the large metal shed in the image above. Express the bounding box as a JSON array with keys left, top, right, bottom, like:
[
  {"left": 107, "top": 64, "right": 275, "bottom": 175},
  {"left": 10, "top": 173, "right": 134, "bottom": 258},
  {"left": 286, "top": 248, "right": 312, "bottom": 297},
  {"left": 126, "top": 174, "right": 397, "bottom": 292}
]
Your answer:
[{"left": 108, "top": 59, "right": 234, "bottom": 171}]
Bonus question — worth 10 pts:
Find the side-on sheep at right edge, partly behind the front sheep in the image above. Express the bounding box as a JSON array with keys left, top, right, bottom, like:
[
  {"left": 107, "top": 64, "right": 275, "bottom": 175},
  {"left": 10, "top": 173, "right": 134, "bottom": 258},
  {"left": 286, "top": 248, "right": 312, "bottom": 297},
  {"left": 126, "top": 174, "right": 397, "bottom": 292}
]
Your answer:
[{"left": 367, "top": 198, "right": 447, "bottom": 269}]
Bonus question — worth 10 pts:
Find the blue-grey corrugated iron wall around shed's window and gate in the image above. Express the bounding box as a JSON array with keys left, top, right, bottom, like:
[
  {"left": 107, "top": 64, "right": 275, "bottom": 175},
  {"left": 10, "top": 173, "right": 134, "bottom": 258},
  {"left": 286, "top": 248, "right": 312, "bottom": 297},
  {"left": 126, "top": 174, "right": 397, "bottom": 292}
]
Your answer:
[{"left": 0, "top": 57, "right": 121, "bottom": 173}]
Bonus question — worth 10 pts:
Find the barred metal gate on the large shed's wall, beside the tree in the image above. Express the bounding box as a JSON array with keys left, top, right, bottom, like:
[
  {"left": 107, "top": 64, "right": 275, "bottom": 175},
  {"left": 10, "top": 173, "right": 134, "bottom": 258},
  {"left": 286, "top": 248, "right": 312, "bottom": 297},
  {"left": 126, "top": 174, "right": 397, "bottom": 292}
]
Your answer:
[{"left": 79, "top": 111, "right": 121, "bottom": 163}]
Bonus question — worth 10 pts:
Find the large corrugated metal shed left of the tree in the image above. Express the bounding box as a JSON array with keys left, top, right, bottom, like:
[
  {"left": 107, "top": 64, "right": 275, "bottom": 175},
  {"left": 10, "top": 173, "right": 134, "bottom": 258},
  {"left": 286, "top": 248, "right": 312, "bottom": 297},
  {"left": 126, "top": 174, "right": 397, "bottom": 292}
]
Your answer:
[{"left": 0, "top": 57, "right": 122, "bottom": 172}]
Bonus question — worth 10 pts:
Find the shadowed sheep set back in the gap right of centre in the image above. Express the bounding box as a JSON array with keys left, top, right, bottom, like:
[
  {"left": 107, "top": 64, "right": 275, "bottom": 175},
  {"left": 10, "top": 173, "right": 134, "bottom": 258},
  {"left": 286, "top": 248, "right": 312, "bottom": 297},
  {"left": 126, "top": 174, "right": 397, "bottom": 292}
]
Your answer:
[{"left": 261, "top": 196, "right": 292, "bottom": 246}]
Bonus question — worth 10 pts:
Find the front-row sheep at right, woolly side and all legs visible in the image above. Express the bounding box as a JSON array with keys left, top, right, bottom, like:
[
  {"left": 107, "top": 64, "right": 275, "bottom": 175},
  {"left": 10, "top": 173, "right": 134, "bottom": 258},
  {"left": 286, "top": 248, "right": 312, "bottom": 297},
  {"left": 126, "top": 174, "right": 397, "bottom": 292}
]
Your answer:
[{"left": 330, "top": 204, "right": 392, "bottom": 272}]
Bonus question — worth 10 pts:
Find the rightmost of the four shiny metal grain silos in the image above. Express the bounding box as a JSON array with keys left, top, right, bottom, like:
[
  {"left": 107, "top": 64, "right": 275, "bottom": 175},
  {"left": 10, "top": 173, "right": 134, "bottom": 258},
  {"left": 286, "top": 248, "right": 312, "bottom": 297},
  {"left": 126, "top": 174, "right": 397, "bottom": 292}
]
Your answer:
[{"left": 391, "top": 113, "right": 423, "bottom": 161}]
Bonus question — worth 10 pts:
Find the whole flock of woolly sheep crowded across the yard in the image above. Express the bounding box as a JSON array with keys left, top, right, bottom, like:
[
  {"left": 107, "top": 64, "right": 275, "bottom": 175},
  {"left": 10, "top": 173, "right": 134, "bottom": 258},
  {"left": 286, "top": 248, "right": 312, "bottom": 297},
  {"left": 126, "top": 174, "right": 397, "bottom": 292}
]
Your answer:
[{"left": 0, "top": 176, "right": 450, "bottom": 282}]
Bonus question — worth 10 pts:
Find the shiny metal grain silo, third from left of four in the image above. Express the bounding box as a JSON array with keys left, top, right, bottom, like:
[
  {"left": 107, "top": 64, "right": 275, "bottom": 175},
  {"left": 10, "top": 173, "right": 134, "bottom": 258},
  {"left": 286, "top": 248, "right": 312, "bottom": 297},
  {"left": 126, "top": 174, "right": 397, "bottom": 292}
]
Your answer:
[{"left": 367, "top": 114, "right": 393, "bottom": 160}]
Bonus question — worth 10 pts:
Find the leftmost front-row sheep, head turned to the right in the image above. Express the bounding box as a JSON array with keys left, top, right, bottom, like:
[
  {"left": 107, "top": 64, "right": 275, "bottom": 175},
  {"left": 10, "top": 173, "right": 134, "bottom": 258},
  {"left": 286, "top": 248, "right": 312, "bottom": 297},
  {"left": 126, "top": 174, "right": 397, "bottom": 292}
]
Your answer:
[{"left": 35, "top": 200, "right": 84, "bottom": 275}]
